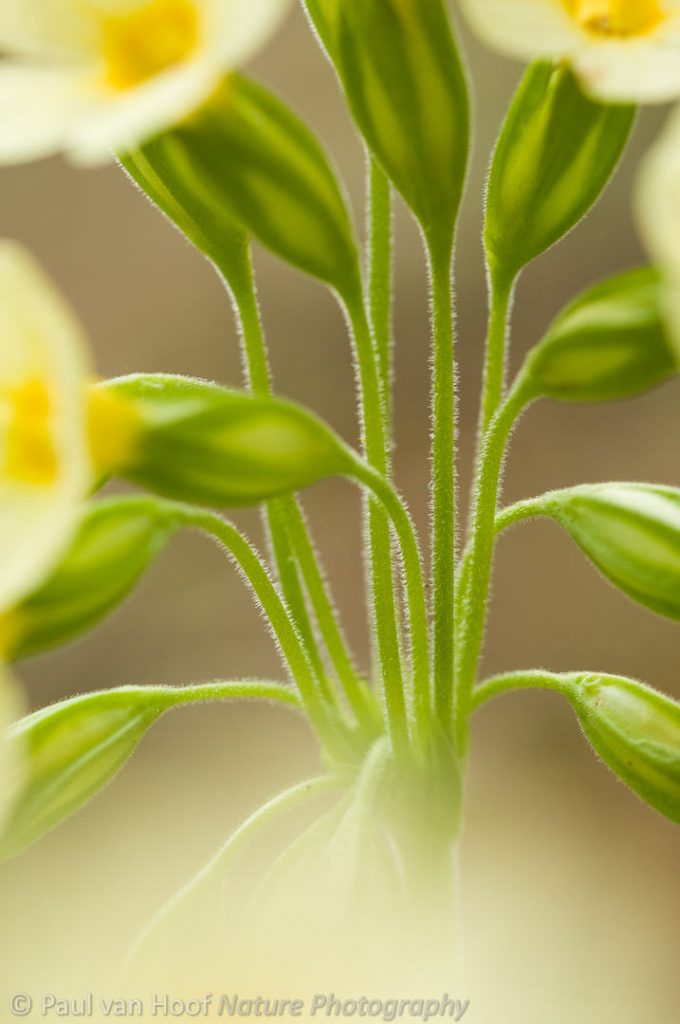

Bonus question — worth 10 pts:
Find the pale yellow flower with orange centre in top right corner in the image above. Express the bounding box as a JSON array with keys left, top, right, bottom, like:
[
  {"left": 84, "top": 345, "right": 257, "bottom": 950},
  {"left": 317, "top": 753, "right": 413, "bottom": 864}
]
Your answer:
[{"left": 463, "top": 0, "right": 680, "bottom": 103}]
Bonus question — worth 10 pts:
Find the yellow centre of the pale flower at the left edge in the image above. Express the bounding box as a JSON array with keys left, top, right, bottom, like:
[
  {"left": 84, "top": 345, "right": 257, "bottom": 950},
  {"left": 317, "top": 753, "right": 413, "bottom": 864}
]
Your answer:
[{"left": 0, "top": 378, "right": 59, "bottom": 487}]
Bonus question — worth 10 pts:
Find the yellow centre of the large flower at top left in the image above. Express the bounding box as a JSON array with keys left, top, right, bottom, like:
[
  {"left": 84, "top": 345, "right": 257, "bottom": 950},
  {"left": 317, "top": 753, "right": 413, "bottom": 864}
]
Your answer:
[{"left": 103, "top": 0, "right": 200, "bottom": 89}]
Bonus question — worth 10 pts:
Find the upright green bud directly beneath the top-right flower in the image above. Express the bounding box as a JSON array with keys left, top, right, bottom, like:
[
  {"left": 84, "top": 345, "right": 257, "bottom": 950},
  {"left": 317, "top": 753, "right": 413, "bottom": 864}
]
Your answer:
[{"left": 484, "top": 61, "right": 635, "bottom": 278}]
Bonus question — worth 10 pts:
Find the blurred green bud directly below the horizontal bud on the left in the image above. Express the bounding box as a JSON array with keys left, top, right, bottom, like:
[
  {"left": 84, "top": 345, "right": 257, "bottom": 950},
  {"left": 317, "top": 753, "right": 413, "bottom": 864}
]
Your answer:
[{"left": 0, "top": 498, "right": 173, "bottom": 659}]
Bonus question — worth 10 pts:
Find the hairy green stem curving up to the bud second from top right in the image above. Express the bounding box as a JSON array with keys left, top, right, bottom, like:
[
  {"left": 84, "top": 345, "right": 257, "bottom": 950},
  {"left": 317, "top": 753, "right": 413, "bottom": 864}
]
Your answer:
[{"left": 456, "top": 379, "right": 533, "bottom": 751}]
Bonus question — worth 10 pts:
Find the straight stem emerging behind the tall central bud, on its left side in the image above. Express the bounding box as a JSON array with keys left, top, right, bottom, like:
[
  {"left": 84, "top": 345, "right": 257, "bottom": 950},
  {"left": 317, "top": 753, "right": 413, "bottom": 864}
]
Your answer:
[{"left": 368, "top": 154, "right": 392, "bottom": 437}]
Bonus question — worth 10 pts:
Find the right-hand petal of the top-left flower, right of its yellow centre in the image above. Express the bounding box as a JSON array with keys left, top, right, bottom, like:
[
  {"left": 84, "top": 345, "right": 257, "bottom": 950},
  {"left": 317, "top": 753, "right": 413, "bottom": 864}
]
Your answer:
[{"left": 206, "top": 0, "right": 291, "bottom": 69}]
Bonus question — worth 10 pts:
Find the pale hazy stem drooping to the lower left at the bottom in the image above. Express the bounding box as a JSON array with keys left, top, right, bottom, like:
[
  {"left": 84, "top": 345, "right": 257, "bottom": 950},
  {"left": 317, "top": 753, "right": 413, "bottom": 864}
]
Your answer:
[{"left": 126, "top": 775, "right": 342, "bottom": 965}]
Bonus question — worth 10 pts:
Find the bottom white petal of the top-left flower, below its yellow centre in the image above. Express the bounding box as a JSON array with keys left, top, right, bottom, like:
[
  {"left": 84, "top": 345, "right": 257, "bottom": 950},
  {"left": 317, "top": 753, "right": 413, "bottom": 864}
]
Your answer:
[{"left": 67, "top": 60, "right": 223, "bottom": 164}]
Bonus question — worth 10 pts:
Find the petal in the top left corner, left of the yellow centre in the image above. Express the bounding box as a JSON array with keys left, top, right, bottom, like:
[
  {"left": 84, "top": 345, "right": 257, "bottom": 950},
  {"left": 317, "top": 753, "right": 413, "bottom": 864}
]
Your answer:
[{"left": 0, "top": 0, "right": 99, "bottom": 56}]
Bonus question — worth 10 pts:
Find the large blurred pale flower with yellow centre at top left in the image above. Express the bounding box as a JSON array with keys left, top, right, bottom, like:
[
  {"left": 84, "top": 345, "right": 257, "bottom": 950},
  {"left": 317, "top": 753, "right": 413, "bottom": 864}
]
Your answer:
[{"left": 0, "top": 0, "right": 288, "bottom": 163}]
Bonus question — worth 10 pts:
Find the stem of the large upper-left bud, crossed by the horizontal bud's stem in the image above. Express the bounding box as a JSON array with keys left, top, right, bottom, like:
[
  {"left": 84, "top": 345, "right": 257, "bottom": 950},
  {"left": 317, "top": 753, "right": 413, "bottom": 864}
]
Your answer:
[{"left": 344, "top": 287, "right": 409, "bottom": 751}]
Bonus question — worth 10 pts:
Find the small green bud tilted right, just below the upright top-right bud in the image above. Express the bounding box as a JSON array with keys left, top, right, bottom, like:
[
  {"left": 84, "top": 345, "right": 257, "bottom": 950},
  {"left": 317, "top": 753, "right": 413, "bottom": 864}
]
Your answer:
[{"left": 524, "top": 267, "right": 678, "bottom": 401}]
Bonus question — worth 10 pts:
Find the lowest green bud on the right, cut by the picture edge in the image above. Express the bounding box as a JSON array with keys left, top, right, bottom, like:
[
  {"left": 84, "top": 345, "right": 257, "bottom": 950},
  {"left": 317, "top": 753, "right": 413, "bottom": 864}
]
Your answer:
[{"left": 565, "top": 676, "right": 680, "bottom": 824}]
